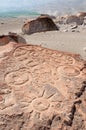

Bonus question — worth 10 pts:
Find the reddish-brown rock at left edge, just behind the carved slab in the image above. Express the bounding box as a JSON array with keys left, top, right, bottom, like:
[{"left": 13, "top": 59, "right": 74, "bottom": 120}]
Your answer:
[{"left": 0, "top": 32, "right": 26, "bottom": 46}]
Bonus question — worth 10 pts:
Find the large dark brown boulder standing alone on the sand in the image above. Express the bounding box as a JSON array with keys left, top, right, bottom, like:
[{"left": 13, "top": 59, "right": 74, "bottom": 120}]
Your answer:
[{"left": 22, "top": 16, "right": 59, "bottom": 34}]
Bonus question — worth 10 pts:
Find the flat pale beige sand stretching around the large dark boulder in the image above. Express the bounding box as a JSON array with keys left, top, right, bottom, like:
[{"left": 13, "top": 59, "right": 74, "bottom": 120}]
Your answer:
[{"left": 0, "top": 17, "right": 86, "bottom": 60}]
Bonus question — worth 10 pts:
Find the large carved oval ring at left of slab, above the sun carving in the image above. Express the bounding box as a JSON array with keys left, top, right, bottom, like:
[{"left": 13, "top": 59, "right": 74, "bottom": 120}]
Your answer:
[{"left": 5, "top": 69, "right": 31, "bottom": 86}]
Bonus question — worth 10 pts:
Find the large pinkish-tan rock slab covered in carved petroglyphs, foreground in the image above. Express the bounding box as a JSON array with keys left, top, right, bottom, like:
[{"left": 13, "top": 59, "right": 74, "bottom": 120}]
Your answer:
[{"left": 0, "top": 43, "right": 86, "bottom": 130}]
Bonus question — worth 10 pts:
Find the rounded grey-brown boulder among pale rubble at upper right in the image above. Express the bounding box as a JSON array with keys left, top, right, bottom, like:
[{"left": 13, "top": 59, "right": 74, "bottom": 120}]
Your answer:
[{"left": 66, "top": 15, "right": 84, "bottom": 25}]
